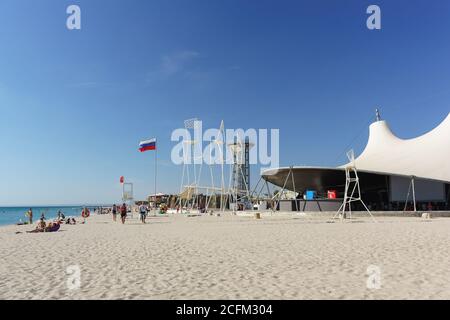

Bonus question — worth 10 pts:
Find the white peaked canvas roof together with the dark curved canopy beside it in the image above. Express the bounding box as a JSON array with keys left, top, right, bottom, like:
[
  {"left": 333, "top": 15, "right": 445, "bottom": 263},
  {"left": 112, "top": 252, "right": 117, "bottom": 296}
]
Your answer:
[{"left": 262, "top": 113, "right": 450, "bottom": 190}]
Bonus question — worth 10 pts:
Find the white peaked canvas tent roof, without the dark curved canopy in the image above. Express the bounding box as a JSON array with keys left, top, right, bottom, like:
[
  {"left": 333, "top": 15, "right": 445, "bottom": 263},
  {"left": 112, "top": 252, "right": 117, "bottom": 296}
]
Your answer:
[{"left": 344, "top": 113, "right": 450, "bottom": 182}]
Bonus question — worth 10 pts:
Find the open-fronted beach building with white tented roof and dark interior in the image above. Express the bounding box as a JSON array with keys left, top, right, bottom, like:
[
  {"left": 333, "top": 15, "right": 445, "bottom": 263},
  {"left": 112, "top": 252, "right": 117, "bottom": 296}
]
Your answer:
[{"left": 262, "top": 112, "right": 450, "bottom": 211}]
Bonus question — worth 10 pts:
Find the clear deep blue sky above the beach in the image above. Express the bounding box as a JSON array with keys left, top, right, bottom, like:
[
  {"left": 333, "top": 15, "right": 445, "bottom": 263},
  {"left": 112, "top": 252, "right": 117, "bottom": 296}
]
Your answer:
[{"left": 0, "top": 0, "right": 450, "bottom": 206}]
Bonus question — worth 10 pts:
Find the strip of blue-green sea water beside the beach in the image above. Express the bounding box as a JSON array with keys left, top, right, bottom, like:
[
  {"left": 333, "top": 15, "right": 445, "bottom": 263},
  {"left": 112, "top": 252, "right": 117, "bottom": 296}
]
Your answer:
[{"left": 0, "top": 206, "right": 101, "bottom": 225}]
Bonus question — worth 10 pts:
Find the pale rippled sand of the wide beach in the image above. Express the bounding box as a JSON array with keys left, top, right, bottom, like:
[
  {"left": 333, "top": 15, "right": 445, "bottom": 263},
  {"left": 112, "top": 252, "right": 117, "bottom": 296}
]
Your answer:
[{"left": 0, "top": 212, "right": 450, "bottom": 299}]
